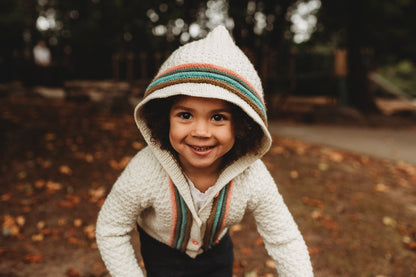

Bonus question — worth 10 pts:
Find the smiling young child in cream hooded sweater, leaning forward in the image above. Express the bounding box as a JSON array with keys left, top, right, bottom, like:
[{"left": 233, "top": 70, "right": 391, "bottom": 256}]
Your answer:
[{"left": 96, "top": 26, "right": 313, "bottom": 277}]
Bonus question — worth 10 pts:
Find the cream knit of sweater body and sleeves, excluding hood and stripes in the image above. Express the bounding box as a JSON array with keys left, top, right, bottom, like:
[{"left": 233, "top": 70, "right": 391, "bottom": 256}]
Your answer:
[{"left": 97, "top": 147, "right": 313, "bottom": 277}]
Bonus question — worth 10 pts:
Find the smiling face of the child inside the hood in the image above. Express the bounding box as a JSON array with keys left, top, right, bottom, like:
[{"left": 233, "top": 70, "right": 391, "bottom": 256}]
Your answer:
[{"left": 169, "top": 96, "right": 235, "bottom": 172}]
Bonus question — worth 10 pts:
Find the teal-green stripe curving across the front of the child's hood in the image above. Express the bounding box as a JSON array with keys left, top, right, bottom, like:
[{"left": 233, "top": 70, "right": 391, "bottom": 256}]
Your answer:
[{"left": 146, "top": 70, "right": 266, "bottom": 114}]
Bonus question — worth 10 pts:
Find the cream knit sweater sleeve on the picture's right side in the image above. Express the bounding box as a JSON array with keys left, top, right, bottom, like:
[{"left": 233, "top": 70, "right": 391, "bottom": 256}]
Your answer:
[{"left": 250, "top": 161, "right": 313, "bottom": 277}]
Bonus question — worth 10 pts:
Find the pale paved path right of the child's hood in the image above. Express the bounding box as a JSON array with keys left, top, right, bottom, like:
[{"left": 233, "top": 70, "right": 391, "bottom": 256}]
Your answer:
[{"left": 269, "top": 122, "right": 416, "bottom": 165}]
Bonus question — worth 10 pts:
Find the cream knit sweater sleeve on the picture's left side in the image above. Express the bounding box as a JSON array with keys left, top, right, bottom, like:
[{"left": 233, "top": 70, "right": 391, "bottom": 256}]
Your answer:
[{"left": 96, "top": 153, "right": 153, "bottom": 277}]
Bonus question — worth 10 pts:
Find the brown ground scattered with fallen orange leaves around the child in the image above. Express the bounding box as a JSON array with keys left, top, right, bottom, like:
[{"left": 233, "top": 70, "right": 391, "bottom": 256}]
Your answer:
[{"left": 0, "top": 95, "right": 416, "bottom": 277}]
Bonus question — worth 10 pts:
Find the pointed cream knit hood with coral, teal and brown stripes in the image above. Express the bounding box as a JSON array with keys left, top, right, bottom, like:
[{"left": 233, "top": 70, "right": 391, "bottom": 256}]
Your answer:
[{"left": 135, "top": 26, "right": 271, "bottom": 194}]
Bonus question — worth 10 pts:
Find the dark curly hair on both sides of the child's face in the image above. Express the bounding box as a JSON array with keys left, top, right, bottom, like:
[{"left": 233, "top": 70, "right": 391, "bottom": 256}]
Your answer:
[{"left": 141, "top": 96, "right": 264, "bottom": 164}]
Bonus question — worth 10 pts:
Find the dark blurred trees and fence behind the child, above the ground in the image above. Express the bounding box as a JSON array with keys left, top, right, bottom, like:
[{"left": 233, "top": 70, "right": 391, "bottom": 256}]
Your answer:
[{"left": 0, "top": 0, "right": 416, "bottom": 113}]
